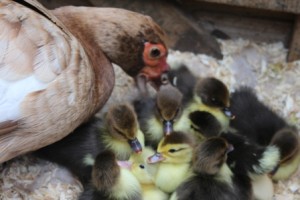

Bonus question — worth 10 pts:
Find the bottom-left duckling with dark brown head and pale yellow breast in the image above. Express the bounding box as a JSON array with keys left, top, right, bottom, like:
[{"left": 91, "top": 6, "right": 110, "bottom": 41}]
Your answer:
[{"left": 79, "top": 150, "right": 143, "bottom": 200}]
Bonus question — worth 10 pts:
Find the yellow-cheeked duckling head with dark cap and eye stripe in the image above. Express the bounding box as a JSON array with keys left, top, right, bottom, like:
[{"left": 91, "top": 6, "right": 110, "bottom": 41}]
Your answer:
[{"left": 147, "top": 131, "right": 195, "bottom": 164}]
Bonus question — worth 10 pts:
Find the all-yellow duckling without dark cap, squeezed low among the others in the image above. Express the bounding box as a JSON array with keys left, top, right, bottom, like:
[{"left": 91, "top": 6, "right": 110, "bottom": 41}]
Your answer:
[{"left": 130, "top": 147, "right": 169, "bottom": 200}]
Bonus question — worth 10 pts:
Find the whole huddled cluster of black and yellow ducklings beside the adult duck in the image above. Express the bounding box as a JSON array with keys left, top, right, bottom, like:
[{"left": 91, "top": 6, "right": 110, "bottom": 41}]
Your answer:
[{"left": 34, "top": 67, "right": 300, "bottom": 200}]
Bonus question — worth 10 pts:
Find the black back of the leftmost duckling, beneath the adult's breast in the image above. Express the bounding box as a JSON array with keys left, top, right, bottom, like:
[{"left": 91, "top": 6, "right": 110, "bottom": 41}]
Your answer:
[{"left": 33, "top": 118, "right": 101, "bottom": 185}]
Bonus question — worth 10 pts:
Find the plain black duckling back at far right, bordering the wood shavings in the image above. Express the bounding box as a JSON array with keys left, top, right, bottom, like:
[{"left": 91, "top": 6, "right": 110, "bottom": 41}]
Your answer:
[{"left": 230, "top": 87, "right": 287, "bottom": 145}]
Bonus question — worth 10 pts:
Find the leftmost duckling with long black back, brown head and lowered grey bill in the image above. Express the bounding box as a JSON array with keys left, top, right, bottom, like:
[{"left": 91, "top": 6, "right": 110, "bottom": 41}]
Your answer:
[{"left": 34, "top": 104, "right": 144, "bottom": 185}]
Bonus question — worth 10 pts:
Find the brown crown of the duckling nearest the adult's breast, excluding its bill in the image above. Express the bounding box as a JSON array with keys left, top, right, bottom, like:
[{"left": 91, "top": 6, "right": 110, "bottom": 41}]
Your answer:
[{"left": 106, "top": 104, "right": 138, "bottom": 140}]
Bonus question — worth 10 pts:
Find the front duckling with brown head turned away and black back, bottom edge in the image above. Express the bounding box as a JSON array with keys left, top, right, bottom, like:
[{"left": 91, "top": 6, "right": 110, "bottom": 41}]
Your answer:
[{"left": 170, "top": 137, "right": 252, "bottom": 200}]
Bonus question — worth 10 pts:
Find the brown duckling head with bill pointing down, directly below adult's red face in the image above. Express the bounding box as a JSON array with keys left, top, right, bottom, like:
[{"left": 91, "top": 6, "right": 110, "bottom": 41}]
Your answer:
[{"left": 156, "top": 84, "right": 182, "bottom": 135}]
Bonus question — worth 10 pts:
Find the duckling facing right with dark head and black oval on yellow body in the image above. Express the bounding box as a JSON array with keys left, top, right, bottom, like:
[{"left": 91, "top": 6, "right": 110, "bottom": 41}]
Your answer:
[{"left": 171, "top": 77, "right": 234, "bottom": 141}]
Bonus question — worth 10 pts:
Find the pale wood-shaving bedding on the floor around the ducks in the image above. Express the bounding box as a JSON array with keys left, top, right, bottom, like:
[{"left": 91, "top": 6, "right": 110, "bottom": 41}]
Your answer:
[{"left": 0, "top": 39, "right": 300, "bottom": 200}]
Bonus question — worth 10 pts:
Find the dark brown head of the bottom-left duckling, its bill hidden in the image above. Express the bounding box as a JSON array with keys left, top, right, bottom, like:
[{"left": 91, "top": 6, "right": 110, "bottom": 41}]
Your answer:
[{"left": 92, "top": 150, "right": 120, "bottom": 191}]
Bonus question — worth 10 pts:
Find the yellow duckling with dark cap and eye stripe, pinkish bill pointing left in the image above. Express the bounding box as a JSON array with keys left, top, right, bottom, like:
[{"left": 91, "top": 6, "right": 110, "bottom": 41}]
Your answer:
[{"left": 147, "top": 131, "right": 194, "bottom": 193}]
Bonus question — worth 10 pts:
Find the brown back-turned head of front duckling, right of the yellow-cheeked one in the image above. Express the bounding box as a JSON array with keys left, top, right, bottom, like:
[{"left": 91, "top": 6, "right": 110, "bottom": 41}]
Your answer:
[{"left": 193, "top": 137, "right": 233, "bottom": 175}]
